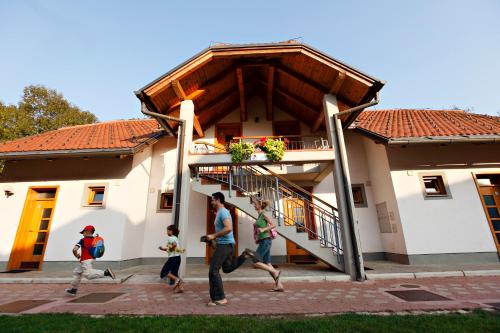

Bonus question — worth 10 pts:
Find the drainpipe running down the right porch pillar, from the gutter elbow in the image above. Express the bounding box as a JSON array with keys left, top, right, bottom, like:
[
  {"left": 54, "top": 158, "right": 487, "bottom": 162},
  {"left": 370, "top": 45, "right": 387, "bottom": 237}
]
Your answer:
[{"left": 333, "top": 93, "right": 379, "bottom": 281}]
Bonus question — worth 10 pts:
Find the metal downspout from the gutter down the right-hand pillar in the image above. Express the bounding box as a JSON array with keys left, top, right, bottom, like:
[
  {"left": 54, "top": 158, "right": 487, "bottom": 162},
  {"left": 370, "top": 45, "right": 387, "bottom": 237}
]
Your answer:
[{"left": 333, "top": 93, "right": 379, "bottom": 281}]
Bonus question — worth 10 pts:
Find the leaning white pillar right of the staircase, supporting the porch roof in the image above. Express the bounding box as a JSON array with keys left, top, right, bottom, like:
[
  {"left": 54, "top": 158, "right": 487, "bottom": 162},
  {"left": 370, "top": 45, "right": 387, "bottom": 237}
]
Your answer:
[{"left": 323, "top": 94, "right": 365, "bottom": 281}]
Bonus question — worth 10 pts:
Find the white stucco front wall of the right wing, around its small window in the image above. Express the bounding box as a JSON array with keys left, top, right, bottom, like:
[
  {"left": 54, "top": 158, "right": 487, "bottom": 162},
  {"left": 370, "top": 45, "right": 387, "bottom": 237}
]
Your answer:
[{"left": 391, "top": 168, "right": 500, "bottom": 254}]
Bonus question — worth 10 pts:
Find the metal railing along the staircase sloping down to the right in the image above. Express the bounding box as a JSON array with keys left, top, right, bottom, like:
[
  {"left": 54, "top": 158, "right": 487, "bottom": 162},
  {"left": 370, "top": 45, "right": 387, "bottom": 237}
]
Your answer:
[{"left": 192, "top": 165, "right": 343, "bottom": 262}]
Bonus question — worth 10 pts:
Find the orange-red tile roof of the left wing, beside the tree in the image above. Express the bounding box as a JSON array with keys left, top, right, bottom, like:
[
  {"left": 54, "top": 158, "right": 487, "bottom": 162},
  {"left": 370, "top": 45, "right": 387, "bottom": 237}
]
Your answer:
[{"left": 0, "top": 119, "right": 160, "bottom": 153}]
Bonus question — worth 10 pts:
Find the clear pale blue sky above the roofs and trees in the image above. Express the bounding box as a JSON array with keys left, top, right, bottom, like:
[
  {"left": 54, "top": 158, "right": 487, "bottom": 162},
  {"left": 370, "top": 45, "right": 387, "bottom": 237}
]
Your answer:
[{"left": 0, "top": 0, "right": 500, "bottom": 121}]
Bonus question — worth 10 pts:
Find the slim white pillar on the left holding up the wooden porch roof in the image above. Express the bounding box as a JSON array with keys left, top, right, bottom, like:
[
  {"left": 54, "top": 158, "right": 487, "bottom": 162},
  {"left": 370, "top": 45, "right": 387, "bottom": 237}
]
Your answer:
[{"left": 172, "top": 100, "right": 194, "bottom": 275}]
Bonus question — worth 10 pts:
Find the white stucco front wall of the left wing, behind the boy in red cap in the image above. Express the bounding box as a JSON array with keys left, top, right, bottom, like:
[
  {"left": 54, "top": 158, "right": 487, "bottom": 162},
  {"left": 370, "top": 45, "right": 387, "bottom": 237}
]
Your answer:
[{"left": 0, "top": 148, "right": 151, "bottom": 261}]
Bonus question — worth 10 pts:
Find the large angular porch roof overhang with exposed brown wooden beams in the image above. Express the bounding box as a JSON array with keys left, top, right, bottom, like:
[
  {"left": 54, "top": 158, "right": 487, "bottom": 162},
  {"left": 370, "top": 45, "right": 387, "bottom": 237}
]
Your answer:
[{"left": 135, "top": 42, "right": 384, "bottom": 132}]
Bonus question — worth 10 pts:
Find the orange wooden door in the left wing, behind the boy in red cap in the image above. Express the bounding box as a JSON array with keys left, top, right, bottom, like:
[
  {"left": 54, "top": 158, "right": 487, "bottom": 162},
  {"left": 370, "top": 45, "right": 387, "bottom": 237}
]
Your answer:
[{"left": 8, "top": 188, "right": 57, "bottom": 270}]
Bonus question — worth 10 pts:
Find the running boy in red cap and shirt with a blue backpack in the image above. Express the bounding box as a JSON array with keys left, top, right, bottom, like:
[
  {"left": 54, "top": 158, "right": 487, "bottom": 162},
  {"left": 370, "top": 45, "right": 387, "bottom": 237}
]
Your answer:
[{"left": 66, "top": 225, "right": 115, "bottom": 296}]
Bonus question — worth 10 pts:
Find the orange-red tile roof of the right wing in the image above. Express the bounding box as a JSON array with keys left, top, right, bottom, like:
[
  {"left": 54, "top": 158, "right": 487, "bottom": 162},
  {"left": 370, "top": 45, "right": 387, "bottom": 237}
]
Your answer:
[{"left": 355, "top": 109, "right": 500, "bottom": 139}]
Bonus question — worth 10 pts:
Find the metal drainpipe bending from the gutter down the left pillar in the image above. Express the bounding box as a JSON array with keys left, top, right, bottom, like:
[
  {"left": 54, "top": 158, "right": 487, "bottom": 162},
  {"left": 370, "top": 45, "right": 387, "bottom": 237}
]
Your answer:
[{"left": 141, "top": 102, "right": 186, "bottom": 227}]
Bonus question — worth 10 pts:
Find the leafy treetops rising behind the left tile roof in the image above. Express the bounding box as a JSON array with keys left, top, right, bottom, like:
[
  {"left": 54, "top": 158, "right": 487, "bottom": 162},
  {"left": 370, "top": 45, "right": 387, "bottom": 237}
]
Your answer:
[{"left": 0, "top": 85, "right": 98, "bottom": 141}]
